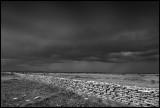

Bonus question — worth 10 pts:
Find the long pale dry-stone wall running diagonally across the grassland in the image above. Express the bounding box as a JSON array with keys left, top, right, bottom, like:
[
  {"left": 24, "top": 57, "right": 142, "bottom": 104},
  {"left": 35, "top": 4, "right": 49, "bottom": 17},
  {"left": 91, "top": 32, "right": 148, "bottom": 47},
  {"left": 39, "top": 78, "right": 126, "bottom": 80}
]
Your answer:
[{"left": 16, "top": 73, "right": 159, "bottom": 107}]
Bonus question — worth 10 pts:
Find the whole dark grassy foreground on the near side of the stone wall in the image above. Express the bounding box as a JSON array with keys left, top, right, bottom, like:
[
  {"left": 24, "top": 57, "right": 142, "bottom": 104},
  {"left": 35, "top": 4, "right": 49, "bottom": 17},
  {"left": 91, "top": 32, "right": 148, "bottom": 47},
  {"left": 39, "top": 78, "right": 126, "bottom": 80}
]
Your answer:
[{"left": 1, "top": 73, "right": 133, "bottom": 107}]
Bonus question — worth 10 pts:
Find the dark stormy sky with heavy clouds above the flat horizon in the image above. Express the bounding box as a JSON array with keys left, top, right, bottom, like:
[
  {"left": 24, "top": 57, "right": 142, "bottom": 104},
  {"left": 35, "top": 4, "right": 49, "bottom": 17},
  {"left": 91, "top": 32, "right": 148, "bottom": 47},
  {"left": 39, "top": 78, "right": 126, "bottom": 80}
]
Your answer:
[{"left": 1, "top": 1, "right": 159, "bottom": 73}]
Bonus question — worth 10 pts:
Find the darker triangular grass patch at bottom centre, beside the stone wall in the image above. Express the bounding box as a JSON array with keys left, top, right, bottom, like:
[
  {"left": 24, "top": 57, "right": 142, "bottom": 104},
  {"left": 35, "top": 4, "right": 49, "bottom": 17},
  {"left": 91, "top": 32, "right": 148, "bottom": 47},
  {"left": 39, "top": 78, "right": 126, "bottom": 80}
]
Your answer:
[{"left": 23, "top": 91, "right": 106, "bottom": 107}]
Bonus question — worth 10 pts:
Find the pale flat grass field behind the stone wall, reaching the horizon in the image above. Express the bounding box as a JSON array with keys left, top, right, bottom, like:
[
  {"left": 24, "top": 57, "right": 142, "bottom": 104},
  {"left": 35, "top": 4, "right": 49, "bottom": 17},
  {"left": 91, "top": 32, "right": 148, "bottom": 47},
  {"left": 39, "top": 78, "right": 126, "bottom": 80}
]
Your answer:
[{"left": 34, "top": 73, "right": 159, "bottom": 88}]
